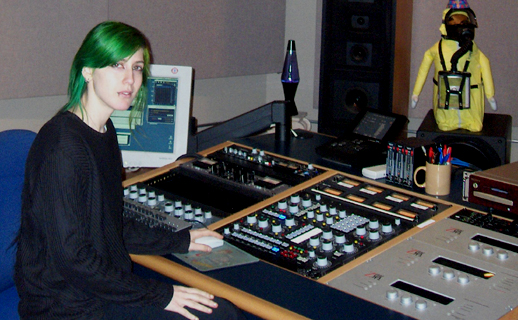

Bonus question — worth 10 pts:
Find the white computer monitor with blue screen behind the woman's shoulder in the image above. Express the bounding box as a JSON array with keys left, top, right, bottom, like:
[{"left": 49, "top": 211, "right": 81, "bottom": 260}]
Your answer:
[{"left": 111, "top": 64, "right": 193, "bottom": 168}]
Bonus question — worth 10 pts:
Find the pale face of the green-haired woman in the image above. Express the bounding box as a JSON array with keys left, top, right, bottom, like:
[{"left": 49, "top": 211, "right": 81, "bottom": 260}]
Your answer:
[{"left": 84, "top": 49, "right": 144, "bottom": 113}]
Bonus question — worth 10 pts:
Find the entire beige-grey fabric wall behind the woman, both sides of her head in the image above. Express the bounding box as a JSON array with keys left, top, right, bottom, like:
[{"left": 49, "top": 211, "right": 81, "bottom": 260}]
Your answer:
[{"left": 0, "top": 0, "right": 286, "bottom": 100}]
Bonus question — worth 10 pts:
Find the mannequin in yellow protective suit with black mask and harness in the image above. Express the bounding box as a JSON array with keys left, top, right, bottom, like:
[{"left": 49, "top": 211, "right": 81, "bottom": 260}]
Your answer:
[{"left": 412, "top": 0, "right": 497, "bottom": 132}]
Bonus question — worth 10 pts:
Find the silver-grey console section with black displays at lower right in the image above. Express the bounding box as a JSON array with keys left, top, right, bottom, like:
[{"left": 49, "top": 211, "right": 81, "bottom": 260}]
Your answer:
[{"left": 328, "top": 209, "right": 518, "bottom": 320}]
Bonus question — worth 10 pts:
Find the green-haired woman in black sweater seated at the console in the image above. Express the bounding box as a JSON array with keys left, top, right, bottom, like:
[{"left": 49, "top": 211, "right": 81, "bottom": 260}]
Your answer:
[{"left": 15, "top": 22, "right": 246, "bottom": 319}]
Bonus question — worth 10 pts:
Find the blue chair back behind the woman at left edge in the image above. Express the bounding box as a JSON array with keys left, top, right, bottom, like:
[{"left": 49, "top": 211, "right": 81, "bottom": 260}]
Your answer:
[{"left": 0, "top": 130, "right": 36, "bottom": 320}]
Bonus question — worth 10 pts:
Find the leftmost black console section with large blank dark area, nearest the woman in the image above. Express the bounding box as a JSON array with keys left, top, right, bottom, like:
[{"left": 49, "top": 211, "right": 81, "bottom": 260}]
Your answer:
[{"left": 124, "top": 145, "right": 325, "bottom": 232}]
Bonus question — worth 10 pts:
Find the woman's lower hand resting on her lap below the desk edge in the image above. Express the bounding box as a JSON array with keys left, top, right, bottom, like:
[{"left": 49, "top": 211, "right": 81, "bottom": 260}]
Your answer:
[{"left": 165, "top": 286, "right": 218, "bottom": 320}]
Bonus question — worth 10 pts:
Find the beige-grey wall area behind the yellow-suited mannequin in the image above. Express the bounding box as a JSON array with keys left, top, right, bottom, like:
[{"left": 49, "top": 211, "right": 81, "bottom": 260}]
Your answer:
[{"left": 409, "top": 0, "right": 518, "bottom": 126}]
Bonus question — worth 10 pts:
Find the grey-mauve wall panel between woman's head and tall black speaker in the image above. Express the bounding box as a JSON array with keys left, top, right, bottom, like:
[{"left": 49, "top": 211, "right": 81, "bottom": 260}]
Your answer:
[{"left": 110, "top": 0, "right": 286, "bottom": 79}]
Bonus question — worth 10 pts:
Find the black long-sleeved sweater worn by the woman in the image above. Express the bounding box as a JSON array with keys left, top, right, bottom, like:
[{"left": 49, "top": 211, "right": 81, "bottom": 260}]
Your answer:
[{"left": 15, "top": 112, "right": 190, "bottom": 319}]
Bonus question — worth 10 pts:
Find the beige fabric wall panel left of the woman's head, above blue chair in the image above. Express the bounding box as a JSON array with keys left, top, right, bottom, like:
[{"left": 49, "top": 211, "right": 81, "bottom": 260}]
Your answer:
[{"left": 0, "top": 0, "right": 108, "bottom": 100}]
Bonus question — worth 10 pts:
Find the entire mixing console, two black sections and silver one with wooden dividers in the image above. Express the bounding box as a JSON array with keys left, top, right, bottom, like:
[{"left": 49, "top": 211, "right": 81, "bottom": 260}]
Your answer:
[{"left": 124, "top": 142, "right": 518, "bottom": 320}]
